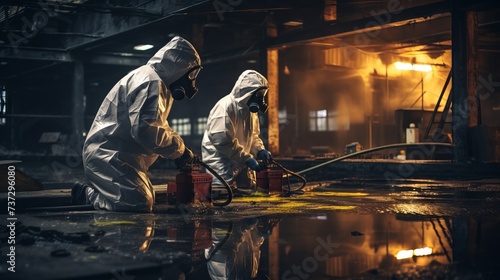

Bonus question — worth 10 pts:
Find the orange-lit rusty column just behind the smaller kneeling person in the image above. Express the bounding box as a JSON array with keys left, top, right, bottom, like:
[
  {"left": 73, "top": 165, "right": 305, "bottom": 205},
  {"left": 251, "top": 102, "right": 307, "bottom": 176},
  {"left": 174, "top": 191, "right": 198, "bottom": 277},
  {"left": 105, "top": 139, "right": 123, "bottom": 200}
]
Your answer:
[{"left": 267, "top": 49, "right": 280, "bottom": 155}]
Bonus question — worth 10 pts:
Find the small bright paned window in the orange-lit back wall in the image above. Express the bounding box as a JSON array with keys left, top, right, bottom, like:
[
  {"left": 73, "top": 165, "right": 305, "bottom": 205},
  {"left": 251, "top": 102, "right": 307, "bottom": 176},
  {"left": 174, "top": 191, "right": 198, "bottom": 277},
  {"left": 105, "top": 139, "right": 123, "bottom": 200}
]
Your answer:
[{"left": 309, "top": 110, "right": 349, "bottom": 131}]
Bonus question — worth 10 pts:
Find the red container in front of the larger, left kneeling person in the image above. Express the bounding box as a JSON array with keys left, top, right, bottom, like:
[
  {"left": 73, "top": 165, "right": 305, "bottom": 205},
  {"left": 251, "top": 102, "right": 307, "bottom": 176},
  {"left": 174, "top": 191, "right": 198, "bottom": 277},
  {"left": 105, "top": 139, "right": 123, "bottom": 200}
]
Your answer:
[{"left": 175, "top": 172, "right": 212, "bottom": 204}]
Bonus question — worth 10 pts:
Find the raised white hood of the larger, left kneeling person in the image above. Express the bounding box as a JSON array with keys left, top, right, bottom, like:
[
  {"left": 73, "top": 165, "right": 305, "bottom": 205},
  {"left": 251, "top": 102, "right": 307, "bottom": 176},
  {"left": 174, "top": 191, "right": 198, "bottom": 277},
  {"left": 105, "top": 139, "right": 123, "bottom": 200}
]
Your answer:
[{"left": 147, "top": 36, "right": 201, "bottom": 85}]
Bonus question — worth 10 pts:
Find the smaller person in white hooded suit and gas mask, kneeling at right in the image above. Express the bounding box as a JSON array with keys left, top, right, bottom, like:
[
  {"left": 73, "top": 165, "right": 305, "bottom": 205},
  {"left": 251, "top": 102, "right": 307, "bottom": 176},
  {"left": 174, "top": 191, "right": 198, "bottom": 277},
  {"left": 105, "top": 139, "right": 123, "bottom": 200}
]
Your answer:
[{"left": 201, "top": 70, "right": 271, "bottom": 198}]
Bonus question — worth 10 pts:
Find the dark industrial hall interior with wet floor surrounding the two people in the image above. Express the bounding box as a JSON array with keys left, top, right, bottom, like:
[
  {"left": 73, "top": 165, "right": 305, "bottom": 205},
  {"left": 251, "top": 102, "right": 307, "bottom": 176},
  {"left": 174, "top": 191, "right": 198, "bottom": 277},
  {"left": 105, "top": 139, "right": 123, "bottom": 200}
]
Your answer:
[{"left": 0, "top": 0, "right": 500, "bottom": 279}]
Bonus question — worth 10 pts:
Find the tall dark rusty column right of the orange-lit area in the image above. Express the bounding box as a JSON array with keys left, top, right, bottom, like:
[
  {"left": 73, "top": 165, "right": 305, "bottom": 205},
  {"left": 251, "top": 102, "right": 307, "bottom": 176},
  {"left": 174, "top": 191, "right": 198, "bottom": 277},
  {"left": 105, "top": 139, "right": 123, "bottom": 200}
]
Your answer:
[{"left": 451, "top": 0, "right": 468, "bottom": 162}]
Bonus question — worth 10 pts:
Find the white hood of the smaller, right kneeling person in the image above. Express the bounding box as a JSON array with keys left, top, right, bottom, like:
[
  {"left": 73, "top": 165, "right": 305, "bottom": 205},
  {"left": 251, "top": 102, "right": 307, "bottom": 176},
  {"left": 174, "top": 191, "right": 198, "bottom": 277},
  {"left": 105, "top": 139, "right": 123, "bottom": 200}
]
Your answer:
[{"left": 230, "top": 70, "right": 268, "bottom": 110}]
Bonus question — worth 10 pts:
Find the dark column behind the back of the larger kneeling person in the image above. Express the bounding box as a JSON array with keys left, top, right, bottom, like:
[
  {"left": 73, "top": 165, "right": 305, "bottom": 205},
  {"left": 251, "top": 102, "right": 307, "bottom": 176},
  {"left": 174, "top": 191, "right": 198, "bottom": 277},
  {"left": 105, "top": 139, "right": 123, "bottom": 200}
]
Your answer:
[{"left": 71, "top": 56, "right": 85, "bottom": 152}]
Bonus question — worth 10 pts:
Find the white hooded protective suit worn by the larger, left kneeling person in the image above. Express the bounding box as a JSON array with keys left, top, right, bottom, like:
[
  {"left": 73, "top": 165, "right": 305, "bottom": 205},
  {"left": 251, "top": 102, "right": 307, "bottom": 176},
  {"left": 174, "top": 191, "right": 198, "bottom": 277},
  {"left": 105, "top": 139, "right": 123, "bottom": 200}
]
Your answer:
[{"left": 83, "top": 37, "right": 201, "bottom": 212}]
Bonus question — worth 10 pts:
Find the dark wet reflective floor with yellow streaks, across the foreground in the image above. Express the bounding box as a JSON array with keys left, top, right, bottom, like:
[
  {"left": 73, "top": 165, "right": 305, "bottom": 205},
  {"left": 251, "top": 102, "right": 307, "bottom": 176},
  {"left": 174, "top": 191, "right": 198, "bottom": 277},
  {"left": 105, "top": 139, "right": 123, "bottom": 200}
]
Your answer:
[{"left": 0, "top": 180, "right": 500, "bottom": 280}]
